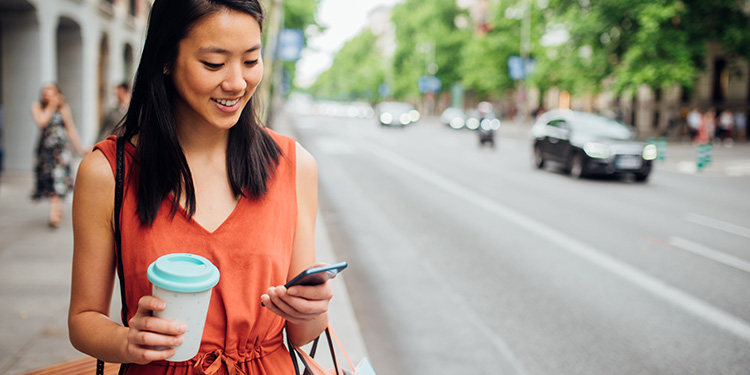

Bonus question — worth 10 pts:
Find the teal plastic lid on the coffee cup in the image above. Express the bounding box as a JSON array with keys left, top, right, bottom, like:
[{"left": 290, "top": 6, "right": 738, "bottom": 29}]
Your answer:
[{"left": 146, "top": 253, "right": 219, "bottom": 293}]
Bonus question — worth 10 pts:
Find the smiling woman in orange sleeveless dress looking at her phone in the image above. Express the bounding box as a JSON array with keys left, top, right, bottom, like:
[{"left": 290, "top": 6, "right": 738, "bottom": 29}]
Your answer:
[{"left": 69, "top": 0, "right": 333, "bottom": 375}]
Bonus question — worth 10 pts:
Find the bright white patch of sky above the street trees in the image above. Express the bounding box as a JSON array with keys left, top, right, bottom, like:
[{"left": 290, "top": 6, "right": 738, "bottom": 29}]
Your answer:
[{"left": 295, "top": 0, "right": 400, "bottom": 87}]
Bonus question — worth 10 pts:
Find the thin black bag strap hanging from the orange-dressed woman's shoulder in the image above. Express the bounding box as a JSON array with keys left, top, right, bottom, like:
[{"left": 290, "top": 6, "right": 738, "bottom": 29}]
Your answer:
[{"left": 96, "top": 137, "right": 128, "bottom": 375}]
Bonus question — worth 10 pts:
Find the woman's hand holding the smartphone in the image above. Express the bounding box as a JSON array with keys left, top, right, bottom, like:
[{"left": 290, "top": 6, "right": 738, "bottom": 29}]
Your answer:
[{"left": 260, "top": 280, "right": 333, "bottom": 324}]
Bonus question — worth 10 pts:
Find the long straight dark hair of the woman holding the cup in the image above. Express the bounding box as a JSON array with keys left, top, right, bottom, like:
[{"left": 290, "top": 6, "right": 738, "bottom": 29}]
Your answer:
[{"left": 123, "top": 0, "right": 281, "bottom": 226}]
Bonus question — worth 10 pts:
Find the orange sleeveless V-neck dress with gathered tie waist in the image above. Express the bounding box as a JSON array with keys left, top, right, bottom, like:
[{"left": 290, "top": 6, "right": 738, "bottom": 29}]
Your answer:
[{"left": 96, "top": 130, "right": 297, "bottom": 375}]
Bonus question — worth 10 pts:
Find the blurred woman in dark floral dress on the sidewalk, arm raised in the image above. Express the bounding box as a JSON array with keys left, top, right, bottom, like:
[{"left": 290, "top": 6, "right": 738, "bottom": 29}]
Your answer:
[{"left": 31, "top": 83, "right": 86, "bottom": 228}]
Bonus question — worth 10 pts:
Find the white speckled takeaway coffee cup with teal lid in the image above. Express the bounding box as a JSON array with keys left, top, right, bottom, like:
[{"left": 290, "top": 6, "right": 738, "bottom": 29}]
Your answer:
[{"left": 147, "top": 253, "right": 219, "bottom": 362}]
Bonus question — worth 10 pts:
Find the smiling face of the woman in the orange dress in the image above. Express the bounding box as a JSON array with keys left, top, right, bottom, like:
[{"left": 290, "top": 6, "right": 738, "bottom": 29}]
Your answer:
[{"left": 169, "top": 10, "right": 263, "bottom": 134}]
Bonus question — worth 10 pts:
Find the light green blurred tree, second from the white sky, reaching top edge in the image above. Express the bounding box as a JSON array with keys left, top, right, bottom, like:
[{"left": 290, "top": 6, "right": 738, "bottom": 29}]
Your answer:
[{"left": 389, "top": 0, "right": 468, "bottom": 99}]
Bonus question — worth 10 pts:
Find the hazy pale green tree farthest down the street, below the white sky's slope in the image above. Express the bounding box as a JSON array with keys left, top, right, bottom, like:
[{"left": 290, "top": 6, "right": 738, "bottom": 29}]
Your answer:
[{"left": 309, "top": 30, "right": 385, "bottom": 103}]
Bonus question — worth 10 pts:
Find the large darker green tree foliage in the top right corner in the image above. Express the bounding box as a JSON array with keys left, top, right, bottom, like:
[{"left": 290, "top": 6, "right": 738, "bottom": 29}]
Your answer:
[{"left": 544, "top": 0, "right": 750, "bottom": 93}]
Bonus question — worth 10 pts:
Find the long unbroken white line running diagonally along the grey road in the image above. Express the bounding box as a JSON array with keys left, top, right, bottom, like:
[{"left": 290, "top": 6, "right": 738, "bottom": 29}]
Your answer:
[{"left": 358, "top": 140, "right": 750, "bottom": 341}]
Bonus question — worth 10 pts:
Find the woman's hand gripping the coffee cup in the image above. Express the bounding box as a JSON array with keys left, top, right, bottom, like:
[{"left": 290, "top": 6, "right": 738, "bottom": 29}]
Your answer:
[{"left": 125, "top": 296, "right": 187, "bottom": 364}]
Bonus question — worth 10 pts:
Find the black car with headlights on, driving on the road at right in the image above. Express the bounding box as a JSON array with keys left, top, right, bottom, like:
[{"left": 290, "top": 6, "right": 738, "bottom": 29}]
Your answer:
[{"left": 531, "top": 110, "right": 657, "bottom": 182}]
